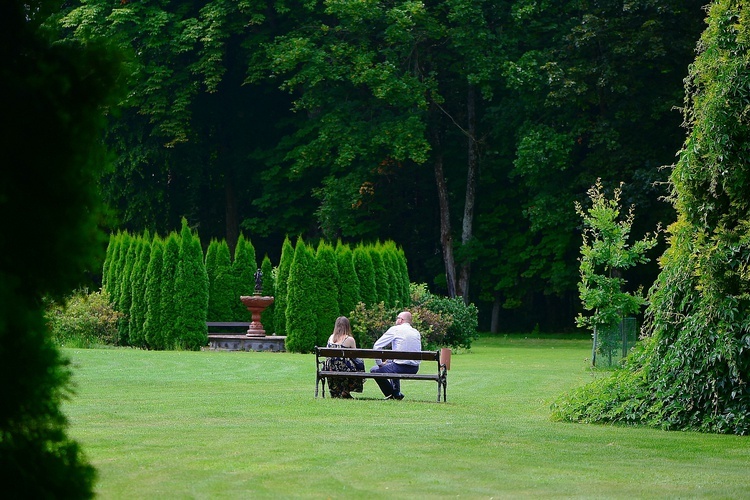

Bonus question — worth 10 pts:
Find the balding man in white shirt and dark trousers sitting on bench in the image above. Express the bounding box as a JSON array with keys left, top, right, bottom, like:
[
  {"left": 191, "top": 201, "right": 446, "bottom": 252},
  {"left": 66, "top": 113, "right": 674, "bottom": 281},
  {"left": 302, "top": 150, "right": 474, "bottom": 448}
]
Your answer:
[{"left": 370, "top": 311, "right": 422, "bottom": 400}]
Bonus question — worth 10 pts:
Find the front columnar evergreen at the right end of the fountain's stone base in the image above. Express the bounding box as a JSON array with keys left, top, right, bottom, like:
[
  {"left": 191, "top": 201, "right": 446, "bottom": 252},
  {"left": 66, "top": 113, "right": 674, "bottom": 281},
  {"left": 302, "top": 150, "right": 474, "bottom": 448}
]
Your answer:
[{"left": 286, "top": 237, "right": 318, "bottom": 352}]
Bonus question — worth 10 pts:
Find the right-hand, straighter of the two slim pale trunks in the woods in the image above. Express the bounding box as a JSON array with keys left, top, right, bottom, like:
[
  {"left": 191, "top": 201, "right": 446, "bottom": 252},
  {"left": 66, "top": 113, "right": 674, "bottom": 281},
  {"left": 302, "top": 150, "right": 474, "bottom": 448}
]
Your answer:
[{"left": 457, "top": 85, "right": 479, "bottom": 303}]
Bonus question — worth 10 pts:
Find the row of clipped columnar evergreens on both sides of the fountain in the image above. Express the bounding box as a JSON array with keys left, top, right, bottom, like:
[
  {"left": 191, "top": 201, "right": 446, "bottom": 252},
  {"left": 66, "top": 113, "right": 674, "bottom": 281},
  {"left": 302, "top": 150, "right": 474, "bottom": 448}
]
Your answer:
[{"left": 103, "top": 225, "right": 410, "bottom": 352}]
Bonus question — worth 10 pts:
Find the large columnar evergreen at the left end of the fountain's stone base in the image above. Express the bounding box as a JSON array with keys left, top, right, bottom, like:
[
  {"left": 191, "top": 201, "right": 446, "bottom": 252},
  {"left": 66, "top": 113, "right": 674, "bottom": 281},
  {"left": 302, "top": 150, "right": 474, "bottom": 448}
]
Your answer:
[{"left": 174, "top": 219, "right": 208, "bottom": 350}]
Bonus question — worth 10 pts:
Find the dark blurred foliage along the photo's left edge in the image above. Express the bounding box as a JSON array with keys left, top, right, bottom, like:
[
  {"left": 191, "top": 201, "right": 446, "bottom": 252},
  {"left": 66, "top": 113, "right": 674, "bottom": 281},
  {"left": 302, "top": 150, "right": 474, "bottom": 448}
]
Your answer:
[{"left": 0, "top": 0, "right": 119, "bottom": 492}]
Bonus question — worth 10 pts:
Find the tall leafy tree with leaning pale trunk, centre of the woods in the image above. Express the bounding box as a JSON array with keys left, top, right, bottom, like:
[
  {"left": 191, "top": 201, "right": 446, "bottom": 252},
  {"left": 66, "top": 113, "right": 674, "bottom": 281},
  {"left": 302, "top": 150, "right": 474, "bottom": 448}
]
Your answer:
[{"left": 270, "top": 0, "right": 507, "bottom": 296}]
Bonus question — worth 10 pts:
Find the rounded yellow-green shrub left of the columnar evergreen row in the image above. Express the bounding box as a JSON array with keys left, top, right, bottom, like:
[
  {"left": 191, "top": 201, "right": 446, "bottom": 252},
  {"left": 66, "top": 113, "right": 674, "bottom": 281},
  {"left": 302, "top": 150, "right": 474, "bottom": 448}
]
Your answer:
[{"left": 45, "top": 289, "right": 123, "bottom": 348}]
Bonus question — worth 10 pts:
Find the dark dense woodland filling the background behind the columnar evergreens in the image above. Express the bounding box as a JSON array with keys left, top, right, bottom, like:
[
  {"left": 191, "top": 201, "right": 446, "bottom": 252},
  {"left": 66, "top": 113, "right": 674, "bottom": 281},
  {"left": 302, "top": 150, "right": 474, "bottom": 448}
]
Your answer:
[{"left": 56, "top": 0, "right": 705, "bottom": 331}]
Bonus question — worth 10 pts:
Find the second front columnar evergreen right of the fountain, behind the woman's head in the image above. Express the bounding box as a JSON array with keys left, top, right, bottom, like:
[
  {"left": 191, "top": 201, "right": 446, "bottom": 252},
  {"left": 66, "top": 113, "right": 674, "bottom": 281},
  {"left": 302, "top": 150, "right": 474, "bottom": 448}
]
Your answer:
[{"left": 314, "top": 241, "right": 339, "bottom": 346}]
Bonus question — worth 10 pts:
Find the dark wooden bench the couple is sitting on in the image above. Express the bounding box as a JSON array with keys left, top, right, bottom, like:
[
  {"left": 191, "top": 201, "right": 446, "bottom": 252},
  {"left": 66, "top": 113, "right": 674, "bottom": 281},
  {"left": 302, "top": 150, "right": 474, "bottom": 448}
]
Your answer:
[{"left": 315, "top": 347, "right": 448, "bottom": 403}]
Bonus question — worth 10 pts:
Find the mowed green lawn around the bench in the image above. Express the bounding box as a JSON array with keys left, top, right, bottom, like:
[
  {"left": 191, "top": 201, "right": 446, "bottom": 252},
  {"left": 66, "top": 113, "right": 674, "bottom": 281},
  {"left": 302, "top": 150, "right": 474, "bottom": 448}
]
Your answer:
[{"left": 64, "top": 336, "right": 750, "bottom": 499}]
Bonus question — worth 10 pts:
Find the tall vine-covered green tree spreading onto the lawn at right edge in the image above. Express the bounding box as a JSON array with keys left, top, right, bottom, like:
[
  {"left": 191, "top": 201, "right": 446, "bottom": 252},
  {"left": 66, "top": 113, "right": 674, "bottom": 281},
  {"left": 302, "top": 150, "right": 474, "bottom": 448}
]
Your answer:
[{"left": 556, "top": 0, "right": 750, "bottom": 434}]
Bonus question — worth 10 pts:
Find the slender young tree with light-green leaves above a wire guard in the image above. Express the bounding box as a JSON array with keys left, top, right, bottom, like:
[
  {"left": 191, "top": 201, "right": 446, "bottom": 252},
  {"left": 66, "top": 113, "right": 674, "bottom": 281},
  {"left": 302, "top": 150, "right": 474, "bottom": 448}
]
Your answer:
[{"left": 575, "top": 179, "right": 657, "bottom": 364}]
